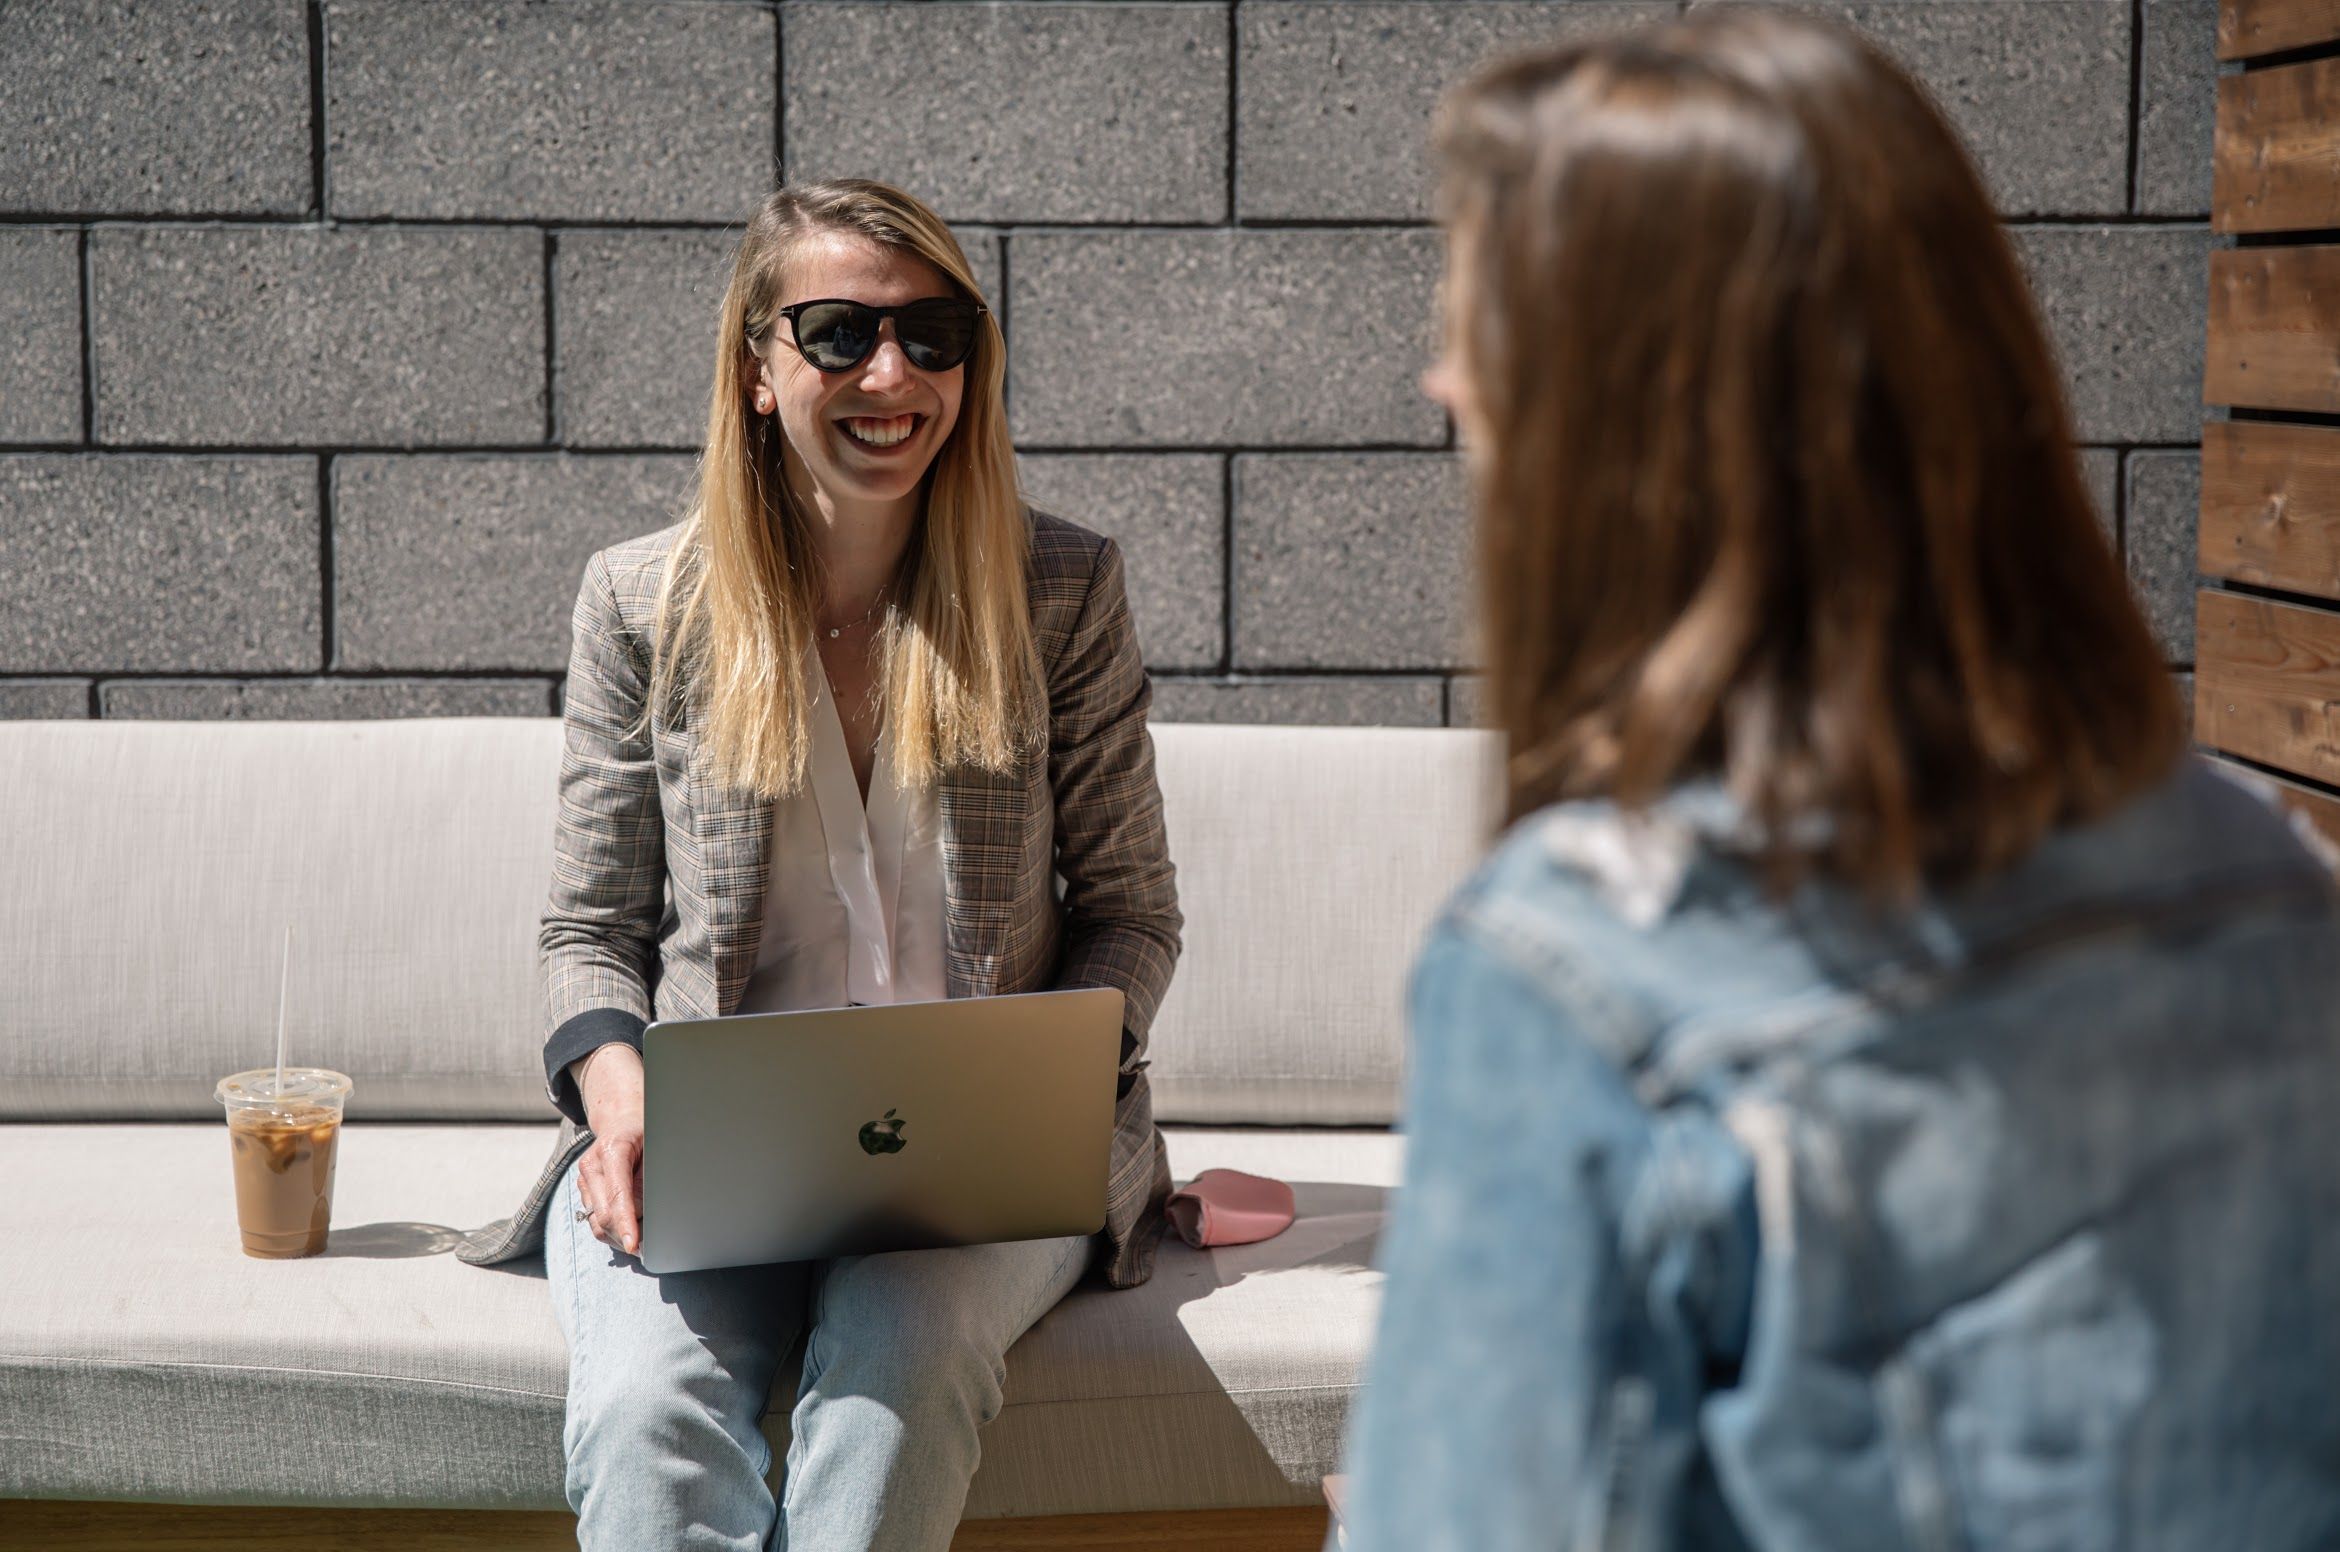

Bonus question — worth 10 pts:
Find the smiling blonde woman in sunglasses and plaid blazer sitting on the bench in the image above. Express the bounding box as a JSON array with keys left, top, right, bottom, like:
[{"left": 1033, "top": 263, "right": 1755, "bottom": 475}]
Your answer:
[{"left": 463, "top": 180, "right": 1182, "bottom": 1552}]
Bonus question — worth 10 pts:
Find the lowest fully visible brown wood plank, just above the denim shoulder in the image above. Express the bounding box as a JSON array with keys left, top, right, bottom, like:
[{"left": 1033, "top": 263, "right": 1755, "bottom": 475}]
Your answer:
[{"left": 2195, "top": 588, "right": 2340, "bottom": 782}]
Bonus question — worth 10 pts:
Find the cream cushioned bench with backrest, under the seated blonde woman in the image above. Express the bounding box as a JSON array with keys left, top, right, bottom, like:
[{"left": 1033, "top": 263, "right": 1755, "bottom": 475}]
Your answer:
[{"left": 0, "top": 719, "right": 1495, "bottom": 1519}]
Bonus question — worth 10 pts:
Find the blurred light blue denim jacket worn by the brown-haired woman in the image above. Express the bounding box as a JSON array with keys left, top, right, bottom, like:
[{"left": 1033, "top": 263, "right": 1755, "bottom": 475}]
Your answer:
[{"left": 1346, "top": 756, "right": 2340, "bottom": 1552}]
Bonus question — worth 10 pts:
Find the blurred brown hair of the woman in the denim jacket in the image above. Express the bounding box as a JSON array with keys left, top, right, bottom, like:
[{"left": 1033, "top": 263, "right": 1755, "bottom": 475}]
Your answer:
[{"left": 1434, "top": 5, "right": 2183, "bottom": 901}]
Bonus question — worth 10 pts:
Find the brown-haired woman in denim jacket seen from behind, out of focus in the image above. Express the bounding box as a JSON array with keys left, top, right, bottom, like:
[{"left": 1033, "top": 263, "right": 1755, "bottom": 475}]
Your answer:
[{"left": 1346, "top": 5, "right": 2340, "bottom": 1552}]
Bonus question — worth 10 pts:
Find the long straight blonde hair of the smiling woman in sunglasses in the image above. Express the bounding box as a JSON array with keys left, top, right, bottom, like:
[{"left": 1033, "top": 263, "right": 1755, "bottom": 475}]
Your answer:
[{"left": 634, "top": 178, "right": 1044, "bottom": 798}]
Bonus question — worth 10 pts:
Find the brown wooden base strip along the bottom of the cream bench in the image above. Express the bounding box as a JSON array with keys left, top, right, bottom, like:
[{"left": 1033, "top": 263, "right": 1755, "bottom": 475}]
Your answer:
[{"left": 0, "top": 1498, "right": 1327, "bottom": 1552}]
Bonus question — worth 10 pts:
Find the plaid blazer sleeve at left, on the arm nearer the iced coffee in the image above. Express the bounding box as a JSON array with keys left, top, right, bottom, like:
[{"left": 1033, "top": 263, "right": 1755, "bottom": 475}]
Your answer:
[{"left": 536, "top": 552, "right": 667, "bottom": 1126}]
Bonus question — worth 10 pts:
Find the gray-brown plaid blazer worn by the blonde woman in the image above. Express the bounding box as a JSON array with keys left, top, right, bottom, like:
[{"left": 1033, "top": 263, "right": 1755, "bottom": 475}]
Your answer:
[{"left": 456, "top": 510, "right": 1184, "bottom": 1287}]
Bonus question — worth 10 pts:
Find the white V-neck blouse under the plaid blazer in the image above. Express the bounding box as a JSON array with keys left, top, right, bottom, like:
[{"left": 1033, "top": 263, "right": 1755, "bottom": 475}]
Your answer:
[{"left": 735, "top": 644, "right": 950, "bottom": 1014}]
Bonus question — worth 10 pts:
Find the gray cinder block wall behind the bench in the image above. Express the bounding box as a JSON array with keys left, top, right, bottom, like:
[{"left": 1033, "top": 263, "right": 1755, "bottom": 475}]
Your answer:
[{"left": 0, "top": 0, "right": 2216, "bottom": 723}]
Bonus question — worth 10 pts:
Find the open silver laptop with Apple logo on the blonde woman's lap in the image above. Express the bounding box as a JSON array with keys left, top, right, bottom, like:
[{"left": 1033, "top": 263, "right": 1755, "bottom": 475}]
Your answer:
[{"left": 639, "top": 988, "right": 1123, "bottom": 1271}]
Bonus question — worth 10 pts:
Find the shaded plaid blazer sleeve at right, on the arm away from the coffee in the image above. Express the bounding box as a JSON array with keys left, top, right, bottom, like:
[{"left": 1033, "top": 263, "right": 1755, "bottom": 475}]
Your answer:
[{"left": 1048, "top": 538, "right": 1184, "bottom": 1096}]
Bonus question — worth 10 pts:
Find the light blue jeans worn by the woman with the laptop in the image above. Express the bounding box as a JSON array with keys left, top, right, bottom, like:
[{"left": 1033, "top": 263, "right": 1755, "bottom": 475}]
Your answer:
[{"left": 545, "top": 1147, "right": 1095, "bottom": 1552}]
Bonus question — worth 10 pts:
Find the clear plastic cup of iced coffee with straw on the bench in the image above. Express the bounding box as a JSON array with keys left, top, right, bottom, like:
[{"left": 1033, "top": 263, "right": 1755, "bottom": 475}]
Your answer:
[{"left": 213, "top": 1067, "right": 349, "bottom": 1259}]
